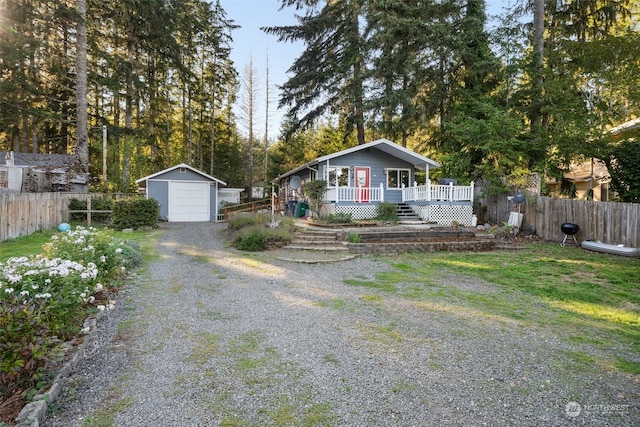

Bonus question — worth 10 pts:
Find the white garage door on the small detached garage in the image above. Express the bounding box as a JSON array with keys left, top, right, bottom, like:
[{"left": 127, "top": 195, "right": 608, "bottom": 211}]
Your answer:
[{"left": 168, "top": 181, "right": 210, "bottom": 222}]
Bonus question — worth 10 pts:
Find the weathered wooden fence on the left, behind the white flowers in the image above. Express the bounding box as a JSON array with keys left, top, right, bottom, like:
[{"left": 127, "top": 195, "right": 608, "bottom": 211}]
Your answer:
[{"left": 0, "top": 193, "right": 96, "bottom": 242}]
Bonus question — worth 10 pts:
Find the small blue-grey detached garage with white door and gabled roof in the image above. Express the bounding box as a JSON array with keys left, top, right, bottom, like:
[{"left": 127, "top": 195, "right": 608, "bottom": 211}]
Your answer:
[{"left": 136, "top": 163, "right": 227, "bottom": 222}]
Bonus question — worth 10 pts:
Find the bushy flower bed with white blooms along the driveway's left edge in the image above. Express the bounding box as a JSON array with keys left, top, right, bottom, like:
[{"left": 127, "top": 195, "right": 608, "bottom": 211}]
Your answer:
[{"left": 0, "top": 227, "right": 141, "bottom": 394}]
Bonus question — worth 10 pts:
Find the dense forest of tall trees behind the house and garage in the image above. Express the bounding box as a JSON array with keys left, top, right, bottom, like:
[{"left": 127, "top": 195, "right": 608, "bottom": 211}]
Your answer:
[{"left": 0, "top": 0, "right": 640, "bottom": 202}]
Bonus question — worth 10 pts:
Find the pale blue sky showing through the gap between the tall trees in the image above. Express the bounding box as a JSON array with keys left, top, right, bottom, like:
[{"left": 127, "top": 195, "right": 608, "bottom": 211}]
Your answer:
[{"left": 220, "top": 0, "right": 515, "bottom": 140}]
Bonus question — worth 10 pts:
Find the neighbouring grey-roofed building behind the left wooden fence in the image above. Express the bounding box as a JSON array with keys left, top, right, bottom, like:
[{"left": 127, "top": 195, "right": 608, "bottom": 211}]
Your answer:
[{"left": 0, "top": 151, "right": 89, "bottom": 193}]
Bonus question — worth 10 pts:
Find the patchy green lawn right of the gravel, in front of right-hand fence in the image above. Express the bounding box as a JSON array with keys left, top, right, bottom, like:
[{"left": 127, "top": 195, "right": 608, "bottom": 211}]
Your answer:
[{"left": 364, "top": 243, "right": 640, "bottom": 372}]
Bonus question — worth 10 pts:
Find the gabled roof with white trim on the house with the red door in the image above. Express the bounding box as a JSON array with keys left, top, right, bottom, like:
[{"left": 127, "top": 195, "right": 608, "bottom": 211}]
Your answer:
[{"left": 272, "top": 138, "right": 440, "bottom": 183}]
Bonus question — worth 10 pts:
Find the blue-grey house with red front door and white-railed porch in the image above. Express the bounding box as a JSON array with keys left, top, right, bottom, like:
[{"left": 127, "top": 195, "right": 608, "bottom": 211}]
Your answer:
[{"left": 272, "top": 139, "right": 473, "bottom": 225}]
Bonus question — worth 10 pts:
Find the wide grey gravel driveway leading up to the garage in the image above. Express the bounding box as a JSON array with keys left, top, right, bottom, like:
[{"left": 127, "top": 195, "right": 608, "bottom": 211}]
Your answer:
[{"left": 44, "top": 223, "right": 640, "bottom": 427}]
